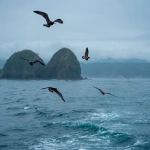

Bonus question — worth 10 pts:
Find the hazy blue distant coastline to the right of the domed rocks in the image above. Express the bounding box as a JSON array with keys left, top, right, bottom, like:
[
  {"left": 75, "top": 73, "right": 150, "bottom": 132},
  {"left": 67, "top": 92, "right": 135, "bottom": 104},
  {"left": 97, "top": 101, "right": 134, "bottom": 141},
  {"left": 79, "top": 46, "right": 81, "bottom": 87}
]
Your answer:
[{"left": 80, "top": 62, "right": 150, "bottom": 78}]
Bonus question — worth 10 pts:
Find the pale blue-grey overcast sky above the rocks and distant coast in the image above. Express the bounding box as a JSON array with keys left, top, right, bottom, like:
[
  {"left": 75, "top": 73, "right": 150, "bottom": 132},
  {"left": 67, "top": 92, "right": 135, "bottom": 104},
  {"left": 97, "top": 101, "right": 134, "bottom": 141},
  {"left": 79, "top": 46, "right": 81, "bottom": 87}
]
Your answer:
[{"left": 0, "top": 0, "right": 150, "bottom": 61}]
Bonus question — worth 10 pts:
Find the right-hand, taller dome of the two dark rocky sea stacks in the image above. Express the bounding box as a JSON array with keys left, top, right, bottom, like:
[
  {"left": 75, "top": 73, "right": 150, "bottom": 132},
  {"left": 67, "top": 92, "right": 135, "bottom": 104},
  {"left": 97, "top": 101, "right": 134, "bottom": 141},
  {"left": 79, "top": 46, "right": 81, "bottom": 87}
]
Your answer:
[{"left": 46, "top": 48, "right": 82, "bottom": 79}]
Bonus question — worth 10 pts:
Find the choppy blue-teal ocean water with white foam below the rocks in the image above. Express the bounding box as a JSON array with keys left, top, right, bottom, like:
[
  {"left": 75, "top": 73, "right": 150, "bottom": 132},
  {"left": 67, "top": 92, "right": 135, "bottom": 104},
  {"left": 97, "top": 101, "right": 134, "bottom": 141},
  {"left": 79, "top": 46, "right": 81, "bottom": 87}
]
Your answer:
[{"left": 0, "top": 78, "right": 150, "bottom": 150}]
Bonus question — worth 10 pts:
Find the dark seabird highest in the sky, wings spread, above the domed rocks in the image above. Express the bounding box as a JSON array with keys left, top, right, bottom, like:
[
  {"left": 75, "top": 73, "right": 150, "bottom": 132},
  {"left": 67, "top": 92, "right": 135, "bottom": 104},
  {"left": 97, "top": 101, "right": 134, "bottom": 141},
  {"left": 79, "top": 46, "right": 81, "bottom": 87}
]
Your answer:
[{"left": 33, "top": 11, "right": 63, "bottom": 27}]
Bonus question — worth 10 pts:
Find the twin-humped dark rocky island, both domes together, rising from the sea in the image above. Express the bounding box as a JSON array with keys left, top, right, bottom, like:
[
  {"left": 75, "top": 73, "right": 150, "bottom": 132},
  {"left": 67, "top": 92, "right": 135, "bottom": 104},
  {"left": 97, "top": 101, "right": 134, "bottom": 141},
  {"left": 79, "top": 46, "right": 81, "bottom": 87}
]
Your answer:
[{"left": 0, "top": 48, "right": 82, "bottom": 80}]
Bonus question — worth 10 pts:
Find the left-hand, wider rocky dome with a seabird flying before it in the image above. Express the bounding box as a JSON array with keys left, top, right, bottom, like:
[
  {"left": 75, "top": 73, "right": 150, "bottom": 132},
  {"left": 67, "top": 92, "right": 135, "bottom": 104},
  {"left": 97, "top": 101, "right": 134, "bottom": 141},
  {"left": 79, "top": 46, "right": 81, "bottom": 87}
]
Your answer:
[{"left": 2, "top": 50, "right": 44, "bottom": 79}]
